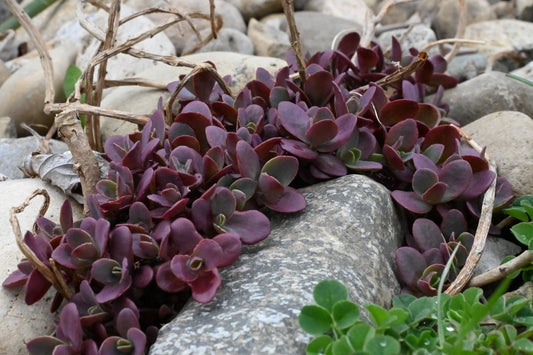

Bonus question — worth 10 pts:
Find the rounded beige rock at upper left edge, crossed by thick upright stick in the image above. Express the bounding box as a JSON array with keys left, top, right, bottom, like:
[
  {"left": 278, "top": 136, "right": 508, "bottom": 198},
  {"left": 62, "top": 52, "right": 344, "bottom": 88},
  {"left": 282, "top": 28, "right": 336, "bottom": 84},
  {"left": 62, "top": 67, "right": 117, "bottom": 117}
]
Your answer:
[{"left": 0, "top": 46, "right": 76, "bottom": 136}]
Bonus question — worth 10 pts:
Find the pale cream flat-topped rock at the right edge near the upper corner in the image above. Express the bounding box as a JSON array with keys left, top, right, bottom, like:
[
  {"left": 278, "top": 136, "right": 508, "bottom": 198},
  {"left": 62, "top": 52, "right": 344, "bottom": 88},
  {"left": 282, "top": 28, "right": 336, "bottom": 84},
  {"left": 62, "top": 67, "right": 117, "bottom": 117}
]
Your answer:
[{"left": 465, "top": 19, "right": 533, "bottom": 56}]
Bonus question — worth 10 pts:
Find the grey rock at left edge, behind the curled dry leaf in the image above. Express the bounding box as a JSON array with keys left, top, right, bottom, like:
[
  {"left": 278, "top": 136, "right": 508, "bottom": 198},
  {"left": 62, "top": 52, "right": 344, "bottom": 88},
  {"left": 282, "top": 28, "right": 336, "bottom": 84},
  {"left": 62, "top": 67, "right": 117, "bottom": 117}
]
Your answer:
[{"left": 0, "top": 137, "right": 68, "bottom": 179}]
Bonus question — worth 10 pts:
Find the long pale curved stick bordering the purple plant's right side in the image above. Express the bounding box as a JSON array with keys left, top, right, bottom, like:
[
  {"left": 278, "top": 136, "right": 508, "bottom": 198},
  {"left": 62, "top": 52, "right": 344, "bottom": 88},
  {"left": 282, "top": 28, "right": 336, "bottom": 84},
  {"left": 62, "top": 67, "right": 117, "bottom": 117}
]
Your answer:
[{"left": 446, "top": 125, "right": 497, "bottom": 296}]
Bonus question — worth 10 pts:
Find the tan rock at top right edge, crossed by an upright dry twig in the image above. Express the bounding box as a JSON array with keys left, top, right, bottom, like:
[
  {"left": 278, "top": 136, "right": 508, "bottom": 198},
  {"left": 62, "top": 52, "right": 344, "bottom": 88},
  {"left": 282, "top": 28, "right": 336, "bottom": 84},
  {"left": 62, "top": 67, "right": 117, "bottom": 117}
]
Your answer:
[{"left": 418, "top": 0, "right": 496, "bottom": 38}]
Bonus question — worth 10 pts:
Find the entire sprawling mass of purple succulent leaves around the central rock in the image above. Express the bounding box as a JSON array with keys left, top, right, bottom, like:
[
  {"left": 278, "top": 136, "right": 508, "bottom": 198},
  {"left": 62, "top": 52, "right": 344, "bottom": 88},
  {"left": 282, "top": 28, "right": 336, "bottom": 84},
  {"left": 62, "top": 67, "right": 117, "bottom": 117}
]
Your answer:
[{"left": 4, "top": 33, "right": 510, "bottom": 354}]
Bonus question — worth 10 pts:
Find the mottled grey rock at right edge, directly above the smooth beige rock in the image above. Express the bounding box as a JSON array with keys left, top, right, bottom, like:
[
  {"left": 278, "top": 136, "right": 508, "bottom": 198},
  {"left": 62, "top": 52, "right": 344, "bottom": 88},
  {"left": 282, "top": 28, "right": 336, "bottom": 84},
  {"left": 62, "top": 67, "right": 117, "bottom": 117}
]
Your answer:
[{"left": 434, "top": 72, "right": 533, "bottom": 126}]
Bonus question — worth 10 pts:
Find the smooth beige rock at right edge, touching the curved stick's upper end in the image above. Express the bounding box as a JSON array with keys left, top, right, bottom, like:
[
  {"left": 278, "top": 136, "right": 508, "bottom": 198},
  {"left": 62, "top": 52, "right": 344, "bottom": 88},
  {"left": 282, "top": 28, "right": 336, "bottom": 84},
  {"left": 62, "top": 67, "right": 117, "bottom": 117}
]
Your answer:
[{"left": 463, "top": 111, "right": 533, "bottom": 196}]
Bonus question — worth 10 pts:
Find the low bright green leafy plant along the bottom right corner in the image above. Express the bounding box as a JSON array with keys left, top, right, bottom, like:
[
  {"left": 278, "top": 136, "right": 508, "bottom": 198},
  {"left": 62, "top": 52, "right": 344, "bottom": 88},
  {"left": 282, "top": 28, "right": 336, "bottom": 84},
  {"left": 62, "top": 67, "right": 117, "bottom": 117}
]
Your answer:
[{"left": 298, "top": 280, "right": 533, "bottom": 355}]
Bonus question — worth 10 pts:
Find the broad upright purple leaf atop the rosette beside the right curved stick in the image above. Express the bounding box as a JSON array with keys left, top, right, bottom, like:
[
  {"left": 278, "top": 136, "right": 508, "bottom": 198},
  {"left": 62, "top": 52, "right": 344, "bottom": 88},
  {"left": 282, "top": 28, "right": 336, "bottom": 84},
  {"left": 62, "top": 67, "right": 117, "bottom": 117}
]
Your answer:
[{"left": 439, "top": 160, "right": 472, "bottom": 202}]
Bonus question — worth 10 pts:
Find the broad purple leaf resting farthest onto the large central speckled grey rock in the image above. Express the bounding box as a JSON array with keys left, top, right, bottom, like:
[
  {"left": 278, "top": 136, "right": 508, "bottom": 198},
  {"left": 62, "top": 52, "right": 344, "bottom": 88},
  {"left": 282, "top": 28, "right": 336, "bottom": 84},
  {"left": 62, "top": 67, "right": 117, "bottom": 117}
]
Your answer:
[{"left": 220, "top": 210, "right": 270, "bottom": 244}]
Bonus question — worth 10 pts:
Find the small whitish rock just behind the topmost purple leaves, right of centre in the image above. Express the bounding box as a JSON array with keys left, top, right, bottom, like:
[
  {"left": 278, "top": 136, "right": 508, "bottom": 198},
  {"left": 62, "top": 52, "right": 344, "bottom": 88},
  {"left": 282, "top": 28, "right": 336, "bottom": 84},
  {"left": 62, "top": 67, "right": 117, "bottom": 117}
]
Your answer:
[{"left": 377, "top": 24, "right": 440, "bottom": 56}]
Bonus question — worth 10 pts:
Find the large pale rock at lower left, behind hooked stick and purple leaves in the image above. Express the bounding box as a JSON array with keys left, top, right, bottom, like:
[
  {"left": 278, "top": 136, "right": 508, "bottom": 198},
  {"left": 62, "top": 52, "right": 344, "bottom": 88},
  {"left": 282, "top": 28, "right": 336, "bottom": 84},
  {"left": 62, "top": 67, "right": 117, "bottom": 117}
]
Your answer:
[{"left": 0, "top": 179, "right": 83, "bottom": 355}]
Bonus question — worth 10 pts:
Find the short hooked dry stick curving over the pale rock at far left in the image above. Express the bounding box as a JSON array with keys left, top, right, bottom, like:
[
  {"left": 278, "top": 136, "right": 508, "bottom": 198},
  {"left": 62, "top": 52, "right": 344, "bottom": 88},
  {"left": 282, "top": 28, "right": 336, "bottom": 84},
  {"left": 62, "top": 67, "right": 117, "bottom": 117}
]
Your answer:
[{"left": 9, "top": 189, "right": 73, "bottom": 299}]
